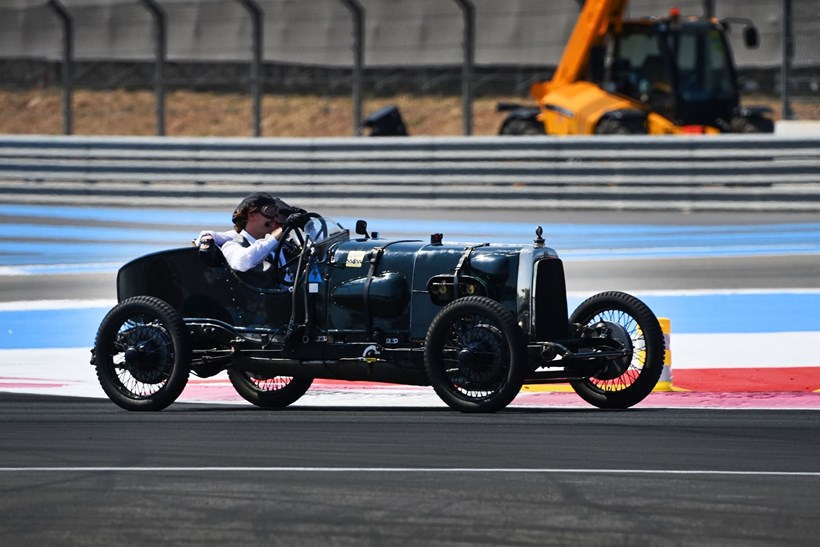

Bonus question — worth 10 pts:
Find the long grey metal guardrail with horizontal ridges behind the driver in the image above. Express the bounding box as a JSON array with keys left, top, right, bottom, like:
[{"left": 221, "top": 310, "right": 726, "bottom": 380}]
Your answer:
[{"left": 0, "top": 135, "right": 820, "bottom": 211}]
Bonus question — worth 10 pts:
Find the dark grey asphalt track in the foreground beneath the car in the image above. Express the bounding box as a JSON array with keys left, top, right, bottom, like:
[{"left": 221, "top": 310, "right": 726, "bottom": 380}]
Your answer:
[{"left": 0, "top": 394, "right": 820, "bottom": 546}]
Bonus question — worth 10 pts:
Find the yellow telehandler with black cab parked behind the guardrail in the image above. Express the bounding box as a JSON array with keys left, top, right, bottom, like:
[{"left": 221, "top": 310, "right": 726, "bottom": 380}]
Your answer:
[{"left": 498, "top": 0, "right": 774, "bottom": 135}]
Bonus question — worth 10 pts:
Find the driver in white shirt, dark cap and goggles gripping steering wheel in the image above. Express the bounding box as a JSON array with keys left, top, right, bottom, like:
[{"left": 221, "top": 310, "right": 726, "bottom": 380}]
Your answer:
[{"left": 194, "top": 192, "right": 305, "bottom": 272}]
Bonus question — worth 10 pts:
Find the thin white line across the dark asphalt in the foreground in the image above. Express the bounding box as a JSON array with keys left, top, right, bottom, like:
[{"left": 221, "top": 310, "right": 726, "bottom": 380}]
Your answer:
[{"left": 0, "top": 466, "right": 820, "bottom": 478}]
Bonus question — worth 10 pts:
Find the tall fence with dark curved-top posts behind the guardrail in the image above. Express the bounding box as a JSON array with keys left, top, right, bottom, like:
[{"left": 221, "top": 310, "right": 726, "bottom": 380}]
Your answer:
[{"left": 0, "top": 0, "right": 820, "bottom": 133}]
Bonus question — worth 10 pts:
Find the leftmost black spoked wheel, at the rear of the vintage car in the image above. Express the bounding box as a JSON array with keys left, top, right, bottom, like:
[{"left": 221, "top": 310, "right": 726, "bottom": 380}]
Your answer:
[{"left": 94, "top": 296, "right": 191, "bottom": 410}]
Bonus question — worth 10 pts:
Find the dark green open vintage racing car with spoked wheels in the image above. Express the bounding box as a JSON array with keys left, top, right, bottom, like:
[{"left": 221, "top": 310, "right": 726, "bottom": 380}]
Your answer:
[{"left": 92, "top": 213, "right": 664, "bottom": 412}]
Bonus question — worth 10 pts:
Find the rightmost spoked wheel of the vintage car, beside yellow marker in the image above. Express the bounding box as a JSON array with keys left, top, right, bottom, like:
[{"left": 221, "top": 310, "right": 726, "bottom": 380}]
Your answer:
[{"left": 570, "top": 292, "right": 664, "bottom": 408}]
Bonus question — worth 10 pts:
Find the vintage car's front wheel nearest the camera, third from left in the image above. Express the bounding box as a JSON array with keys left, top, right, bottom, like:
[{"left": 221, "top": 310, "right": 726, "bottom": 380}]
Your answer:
[{"left": 424, "top": 296, "right": 527, "bottom": 412}]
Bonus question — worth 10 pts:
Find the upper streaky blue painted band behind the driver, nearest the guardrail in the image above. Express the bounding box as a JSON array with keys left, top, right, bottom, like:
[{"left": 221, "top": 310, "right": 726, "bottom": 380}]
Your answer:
[{"left": 0, "top": 205, "right": 820, "bottom": 273}]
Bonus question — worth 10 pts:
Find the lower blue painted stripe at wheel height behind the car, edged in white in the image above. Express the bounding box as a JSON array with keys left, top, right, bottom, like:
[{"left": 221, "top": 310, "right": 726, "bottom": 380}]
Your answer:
[{"left": 0, "top": 292, "right": 820, "bottom": 349}]
